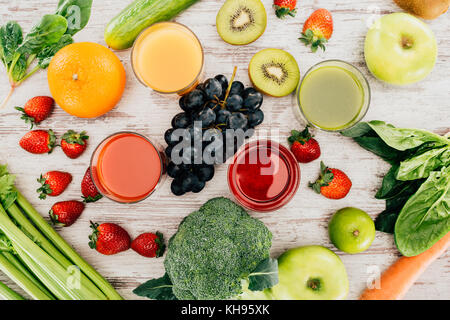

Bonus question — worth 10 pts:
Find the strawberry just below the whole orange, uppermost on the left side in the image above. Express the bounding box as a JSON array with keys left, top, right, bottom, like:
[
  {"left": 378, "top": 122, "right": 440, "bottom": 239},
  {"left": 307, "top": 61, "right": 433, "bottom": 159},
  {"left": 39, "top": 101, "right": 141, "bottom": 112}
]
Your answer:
[{"left": 16, "top": 96, "right": 55, "bottom": 129}]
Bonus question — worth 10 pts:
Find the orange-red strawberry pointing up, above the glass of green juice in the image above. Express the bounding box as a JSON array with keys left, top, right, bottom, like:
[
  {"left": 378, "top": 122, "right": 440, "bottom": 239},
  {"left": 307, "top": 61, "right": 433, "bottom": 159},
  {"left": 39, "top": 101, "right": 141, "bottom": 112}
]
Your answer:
[{"left": 299, "top": 9, "right": 333, "bottom": 52}]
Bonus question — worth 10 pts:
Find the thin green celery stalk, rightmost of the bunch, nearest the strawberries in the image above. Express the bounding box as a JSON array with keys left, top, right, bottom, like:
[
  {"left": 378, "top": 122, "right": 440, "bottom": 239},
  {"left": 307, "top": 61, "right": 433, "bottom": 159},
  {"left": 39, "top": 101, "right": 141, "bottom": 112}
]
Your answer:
[{"left": 14, "top": 192, "right": 123, "bottom": 300}]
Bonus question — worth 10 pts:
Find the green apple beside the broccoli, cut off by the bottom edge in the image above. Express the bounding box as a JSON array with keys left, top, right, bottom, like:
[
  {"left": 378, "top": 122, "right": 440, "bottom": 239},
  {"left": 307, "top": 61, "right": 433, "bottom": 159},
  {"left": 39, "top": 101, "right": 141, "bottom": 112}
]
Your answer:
[{"left": 270, "top": 246, "right": 348, "bottom": 300}]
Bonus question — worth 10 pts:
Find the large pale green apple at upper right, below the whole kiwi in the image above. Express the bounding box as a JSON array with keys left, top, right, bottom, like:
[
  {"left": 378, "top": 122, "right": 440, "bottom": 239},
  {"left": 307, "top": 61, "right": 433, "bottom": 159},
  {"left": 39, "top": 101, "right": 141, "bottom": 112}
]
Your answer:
[{"left": 364, "top": 12, "right": 437, "bottom": 85}]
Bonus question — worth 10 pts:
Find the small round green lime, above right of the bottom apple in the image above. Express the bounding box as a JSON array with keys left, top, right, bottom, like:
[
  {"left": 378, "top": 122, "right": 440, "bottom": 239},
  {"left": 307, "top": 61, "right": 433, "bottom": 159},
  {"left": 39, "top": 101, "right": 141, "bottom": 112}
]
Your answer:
[{"left": 328, "top": 208, "right": 375, "bottom": 253}]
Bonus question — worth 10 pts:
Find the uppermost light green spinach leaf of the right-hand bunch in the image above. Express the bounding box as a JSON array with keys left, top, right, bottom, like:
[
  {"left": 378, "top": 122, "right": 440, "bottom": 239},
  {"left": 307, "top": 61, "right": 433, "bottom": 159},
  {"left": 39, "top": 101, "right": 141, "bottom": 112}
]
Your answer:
[{"left": 368, "top": 121, "right": 450, "bottom": 151}]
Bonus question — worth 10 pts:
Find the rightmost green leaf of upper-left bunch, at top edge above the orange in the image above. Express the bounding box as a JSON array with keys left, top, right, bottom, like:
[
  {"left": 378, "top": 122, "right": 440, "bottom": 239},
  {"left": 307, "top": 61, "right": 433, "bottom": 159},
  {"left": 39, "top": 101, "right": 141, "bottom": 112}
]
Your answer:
[{"left": 56, "top": 0, "right": 92, "bottom": 36}]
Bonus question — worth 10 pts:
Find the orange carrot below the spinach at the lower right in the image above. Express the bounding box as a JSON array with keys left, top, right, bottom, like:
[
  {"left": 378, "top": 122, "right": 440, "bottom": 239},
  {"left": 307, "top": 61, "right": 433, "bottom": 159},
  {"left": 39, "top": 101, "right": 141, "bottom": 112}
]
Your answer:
[{"left": 359, "top": 232, "right": 450, "bottom": 300}]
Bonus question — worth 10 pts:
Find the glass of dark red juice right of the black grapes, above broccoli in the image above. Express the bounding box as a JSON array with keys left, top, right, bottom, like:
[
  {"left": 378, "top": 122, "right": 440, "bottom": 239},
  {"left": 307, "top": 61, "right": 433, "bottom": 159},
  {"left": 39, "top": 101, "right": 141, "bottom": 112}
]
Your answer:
[{"left": 228, "top": 140, "right": 300, "bottom": 212}]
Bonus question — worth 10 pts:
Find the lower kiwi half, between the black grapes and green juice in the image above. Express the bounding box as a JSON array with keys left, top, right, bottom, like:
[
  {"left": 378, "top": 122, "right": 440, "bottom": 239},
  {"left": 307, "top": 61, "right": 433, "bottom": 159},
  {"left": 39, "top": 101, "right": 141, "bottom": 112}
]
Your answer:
[{"left": 248, "top": 49, "right": 300, "bottom": 97}]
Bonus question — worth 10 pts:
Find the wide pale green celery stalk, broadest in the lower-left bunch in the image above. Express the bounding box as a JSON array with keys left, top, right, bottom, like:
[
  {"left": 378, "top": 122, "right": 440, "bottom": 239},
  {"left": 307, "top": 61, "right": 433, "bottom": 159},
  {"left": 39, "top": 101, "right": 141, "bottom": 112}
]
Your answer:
[{"left": 0, "top": 206, "right": 93, "bottom": 300}]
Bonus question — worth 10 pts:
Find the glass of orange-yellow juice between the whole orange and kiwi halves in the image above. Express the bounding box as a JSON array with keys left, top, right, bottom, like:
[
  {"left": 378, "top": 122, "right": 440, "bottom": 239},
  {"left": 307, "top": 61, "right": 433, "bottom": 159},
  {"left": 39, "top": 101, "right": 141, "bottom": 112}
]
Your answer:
[{"left": 131, "top": 22, "right": 204, "bottom": 95}]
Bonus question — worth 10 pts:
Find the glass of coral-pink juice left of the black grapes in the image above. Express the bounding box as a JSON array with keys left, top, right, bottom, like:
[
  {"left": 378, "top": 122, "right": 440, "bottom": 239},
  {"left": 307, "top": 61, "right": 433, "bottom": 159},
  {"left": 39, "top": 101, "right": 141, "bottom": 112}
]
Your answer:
[{"left": 91, "top": 132, "right": 167, "bottom": 203}]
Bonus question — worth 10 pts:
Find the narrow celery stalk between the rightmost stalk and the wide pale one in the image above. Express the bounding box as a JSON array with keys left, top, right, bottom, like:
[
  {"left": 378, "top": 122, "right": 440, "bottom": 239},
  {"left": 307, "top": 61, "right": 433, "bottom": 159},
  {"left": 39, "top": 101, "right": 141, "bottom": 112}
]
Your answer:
[{"left": 7, "top": 204, "right": 106, "bottom": 300}]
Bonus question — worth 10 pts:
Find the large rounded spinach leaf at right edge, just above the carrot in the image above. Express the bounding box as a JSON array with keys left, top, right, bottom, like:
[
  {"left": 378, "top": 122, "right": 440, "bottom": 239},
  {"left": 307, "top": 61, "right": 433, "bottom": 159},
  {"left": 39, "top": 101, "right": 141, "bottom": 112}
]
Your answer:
[{"left": 394, "top": 167, "right": 450, "bottom": 257}]
